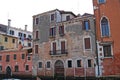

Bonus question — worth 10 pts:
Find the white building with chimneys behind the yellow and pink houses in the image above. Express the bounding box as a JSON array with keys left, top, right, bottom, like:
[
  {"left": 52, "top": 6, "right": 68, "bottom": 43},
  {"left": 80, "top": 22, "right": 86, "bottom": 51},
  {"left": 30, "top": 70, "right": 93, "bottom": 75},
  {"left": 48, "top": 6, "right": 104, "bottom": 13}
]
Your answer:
[{"left": 7, "top": 19, "right": 33, "bottom": 47}]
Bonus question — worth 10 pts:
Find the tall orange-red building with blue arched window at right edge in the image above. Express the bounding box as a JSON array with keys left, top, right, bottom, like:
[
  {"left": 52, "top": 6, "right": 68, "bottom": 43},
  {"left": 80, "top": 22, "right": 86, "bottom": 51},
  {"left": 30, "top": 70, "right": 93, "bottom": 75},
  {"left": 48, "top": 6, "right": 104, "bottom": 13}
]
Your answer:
[{"left": 93, "top": 0, "right": 120, "bottom": 76}]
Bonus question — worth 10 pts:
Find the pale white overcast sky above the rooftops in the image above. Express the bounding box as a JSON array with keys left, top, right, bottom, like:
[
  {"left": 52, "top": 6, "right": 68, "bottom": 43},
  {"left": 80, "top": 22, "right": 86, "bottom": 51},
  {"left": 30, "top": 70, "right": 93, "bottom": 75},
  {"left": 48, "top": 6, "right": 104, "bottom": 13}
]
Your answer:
[{"left": 0, "top": 0, "right": 93, "bottom": 31}]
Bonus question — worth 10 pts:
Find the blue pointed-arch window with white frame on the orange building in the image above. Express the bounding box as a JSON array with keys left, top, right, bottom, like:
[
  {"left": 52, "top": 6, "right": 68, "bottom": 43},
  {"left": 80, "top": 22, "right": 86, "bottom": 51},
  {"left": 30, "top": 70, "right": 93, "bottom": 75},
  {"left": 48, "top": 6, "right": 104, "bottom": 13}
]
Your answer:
[{"left": 101, "top": 17, "right": 110, "bottom": 36}]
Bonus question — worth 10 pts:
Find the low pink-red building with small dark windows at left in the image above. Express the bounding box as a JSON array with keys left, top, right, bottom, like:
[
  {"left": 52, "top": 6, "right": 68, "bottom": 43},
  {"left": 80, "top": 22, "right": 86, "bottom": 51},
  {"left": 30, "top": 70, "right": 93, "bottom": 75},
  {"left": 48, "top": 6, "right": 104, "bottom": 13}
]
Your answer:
[{"left": 0, "top": 45, "right": 32, "bottom": 78}]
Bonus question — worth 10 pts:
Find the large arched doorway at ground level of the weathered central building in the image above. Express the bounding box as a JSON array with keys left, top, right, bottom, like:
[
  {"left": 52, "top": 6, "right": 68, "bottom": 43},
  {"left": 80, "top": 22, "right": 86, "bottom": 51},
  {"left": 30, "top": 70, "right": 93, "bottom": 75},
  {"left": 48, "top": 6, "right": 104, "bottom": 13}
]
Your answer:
[{"left": 55, "top": 60, "right": 64, "bottom": 76}]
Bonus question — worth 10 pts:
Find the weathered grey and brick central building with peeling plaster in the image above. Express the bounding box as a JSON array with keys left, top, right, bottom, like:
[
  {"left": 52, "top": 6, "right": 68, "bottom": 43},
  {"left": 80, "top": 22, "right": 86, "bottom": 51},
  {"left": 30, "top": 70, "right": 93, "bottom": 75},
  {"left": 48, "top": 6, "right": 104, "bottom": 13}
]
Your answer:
[{"left": 33, "top": 9, "right": 96, "bottom": 77}]
